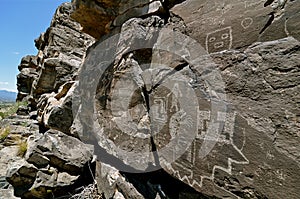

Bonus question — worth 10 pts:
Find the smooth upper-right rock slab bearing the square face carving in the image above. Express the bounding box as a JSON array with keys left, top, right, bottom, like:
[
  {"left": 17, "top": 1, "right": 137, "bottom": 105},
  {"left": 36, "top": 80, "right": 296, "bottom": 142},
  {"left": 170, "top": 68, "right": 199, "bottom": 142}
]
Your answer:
[{"left": 171, "top": 0, "right": 299, "bottom": 53}]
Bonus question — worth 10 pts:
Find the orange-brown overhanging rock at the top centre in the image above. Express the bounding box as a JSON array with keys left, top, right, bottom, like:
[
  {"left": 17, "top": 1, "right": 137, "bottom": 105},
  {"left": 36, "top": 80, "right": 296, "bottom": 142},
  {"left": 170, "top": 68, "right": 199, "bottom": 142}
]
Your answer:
[{"left": 72, "top": 0, "right": 165, "bottom": 39}]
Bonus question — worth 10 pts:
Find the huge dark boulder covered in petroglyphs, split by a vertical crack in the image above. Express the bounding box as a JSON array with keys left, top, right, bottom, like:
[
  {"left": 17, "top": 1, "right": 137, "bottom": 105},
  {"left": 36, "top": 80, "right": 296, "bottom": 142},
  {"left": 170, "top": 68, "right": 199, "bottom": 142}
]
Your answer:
[{"left": 74, "top": 0, "right": 300, "bottom": 198}]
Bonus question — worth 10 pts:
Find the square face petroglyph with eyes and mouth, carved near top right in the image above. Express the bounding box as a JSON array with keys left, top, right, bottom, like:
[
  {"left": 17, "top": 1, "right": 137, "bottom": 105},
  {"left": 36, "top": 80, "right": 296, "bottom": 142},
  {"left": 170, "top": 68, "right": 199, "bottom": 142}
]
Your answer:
[{"left": 206, "top": 27, "right": 232, "bottom": 53}]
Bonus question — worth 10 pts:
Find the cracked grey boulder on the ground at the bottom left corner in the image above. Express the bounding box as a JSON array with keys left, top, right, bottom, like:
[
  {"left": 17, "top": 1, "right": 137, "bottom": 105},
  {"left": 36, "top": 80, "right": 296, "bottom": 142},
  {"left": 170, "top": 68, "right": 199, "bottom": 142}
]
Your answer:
[{"left": 6, "top": 130, "right": 93, "bottom": 198}]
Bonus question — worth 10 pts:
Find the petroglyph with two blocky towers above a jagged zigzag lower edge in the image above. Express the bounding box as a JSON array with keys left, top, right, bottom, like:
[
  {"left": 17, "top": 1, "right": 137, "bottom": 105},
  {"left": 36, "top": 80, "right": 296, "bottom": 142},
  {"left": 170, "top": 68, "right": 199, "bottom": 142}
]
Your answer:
[{"left": 166, "top": 111, "right": 249, "bottom": 198}]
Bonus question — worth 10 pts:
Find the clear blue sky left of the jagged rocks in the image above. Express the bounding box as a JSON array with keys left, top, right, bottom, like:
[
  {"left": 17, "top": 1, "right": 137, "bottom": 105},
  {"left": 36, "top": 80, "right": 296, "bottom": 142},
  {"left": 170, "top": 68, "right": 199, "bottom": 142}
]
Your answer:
[{"left": 0, "top": 0, "right": 70, "bottom": 91}]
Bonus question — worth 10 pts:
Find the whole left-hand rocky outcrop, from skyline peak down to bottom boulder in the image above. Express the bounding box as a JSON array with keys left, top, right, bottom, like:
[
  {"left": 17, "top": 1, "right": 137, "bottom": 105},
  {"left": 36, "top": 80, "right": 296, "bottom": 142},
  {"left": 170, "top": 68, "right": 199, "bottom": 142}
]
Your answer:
[{"left": 0, "top": 3, "right": 94, "bottom": 199}]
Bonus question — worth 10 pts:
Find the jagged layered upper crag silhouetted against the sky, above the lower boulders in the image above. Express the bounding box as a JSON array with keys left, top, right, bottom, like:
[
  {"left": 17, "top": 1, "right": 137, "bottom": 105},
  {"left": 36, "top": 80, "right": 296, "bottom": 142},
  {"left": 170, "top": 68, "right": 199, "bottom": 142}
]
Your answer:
[{"left": 18, "top": 3, "right": 94, "bottom": 104}]
